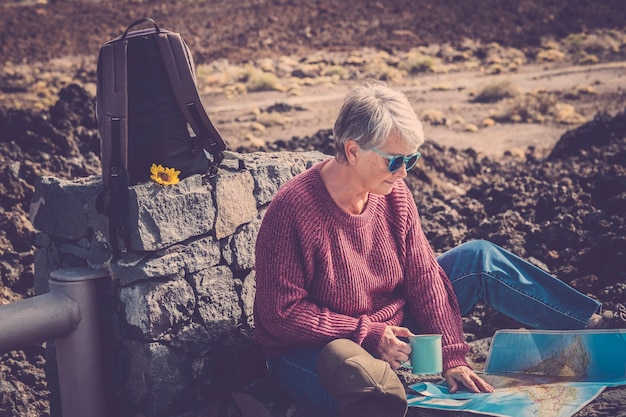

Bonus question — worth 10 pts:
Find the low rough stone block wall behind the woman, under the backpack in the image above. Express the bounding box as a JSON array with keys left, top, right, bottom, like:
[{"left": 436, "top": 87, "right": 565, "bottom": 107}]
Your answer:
[{"left": 31, "top": 152, "right": 328, "bottom": 417}]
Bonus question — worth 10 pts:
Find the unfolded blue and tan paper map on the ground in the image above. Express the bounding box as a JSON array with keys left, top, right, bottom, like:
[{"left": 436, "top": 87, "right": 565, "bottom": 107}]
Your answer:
[{"left": 408, "top": 330, "right": 626, "bottom": 417}]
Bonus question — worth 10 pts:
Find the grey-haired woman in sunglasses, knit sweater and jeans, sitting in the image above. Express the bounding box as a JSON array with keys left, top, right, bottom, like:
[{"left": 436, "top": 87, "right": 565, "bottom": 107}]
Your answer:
[{"left": 255, "top": 85, "right": 626, "bottom": 413}]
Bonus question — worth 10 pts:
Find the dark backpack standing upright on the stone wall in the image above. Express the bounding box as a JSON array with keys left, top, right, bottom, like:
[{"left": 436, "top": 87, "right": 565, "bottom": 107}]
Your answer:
[{"left": 96, "top": 18, "right": 226, "bottom": 259}]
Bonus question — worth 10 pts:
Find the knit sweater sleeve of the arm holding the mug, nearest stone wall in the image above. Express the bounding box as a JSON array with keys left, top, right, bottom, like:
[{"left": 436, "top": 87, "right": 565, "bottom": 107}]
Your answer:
[{"left": 255, "top": 191, "right": 386, "bottom": 352}]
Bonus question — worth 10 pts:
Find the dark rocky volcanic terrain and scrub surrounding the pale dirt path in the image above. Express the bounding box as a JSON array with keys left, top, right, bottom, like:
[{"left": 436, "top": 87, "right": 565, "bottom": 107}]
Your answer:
[{"left": 0, "top": 0, "right": 626, "bottom": 417}]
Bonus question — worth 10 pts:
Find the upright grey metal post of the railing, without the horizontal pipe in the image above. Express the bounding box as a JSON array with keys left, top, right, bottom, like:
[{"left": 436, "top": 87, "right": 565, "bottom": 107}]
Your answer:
[{"left": 50, "top": 268, "right": 108, "bottom": 417}]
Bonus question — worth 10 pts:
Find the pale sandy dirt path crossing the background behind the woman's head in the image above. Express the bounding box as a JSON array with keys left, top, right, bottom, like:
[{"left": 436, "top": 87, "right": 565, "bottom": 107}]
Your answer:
[{"left": 204, "top": 62, "right": 626, "bottom": 156}]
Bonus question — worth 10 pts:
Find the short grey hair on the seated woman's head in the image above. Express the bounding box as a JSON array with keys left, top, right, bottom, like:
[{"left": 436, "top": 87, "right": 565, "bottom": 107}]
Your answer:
[{"left": 333, "top": 84, "right": 424, "bottom": 161}]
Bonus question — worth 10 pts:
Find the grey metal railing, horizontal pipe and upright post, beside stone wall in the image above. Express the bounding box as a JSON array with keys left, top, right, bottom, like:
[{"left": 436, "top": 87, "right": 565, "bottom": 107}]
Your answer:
[{"left": 0, "top": 268, "right": 109, "bottom": 417}]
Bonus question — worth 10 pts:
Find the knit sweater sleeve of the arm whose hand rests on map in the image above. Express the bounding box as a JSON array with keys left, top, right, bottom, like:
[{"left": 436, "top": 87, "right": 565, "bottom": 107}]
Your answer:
[{"left": 405, "top": 184, "right": 469, "bottom": 371}]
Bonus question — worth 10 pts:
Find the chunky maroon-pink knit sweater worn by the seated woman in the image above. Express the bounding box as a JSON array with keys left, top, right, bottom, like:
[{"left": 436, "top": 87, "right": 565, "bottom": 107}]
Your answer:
[{"left": 254, "top": 161, "right": 468, "bottom": 370}]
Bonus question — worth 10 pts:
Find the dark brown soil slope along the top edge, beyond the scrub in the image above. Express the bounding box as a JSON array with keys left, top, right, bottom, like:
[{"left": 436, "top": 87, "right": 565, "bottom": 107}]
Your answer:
[{"left": 0, "top": 0, "right": 626, "bottom": 63}]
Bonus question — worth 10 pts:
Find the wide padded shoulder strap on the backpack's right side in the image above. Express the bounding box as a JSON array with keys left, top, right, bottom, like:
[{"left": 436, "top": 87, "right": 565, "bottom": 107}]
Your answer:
[{"left": 157, "top": 30, "right": 226, "bottom": 168}]
